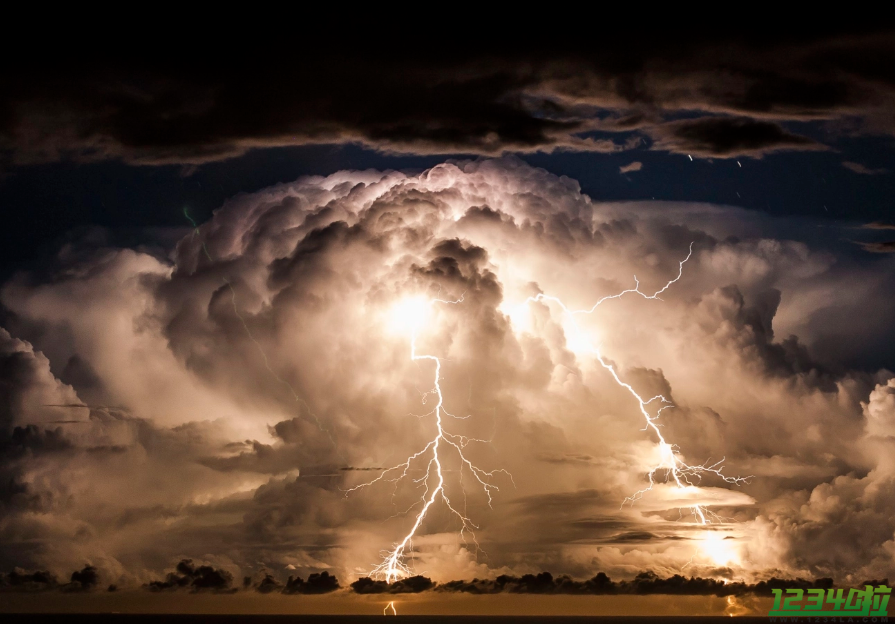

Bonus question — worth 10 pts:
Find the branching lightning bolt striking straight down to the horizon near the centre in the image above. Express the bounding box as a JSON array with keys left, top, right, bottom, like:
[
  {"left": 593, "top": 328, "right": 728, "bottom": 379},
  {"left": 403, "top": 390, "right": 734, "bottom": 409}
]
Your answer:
[{"left": 345, "top": 296, "right": 513, "bottom": 584}]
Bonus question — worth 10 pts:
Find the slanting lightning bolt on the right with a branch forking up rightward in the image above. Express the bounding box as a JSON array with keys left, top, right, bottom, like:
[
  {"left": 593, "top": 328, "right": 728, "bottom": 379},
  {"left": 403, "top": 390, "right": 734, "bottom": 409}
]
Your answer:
[{"left": 523, "top": 243, "right": 752, "bottom": 524}]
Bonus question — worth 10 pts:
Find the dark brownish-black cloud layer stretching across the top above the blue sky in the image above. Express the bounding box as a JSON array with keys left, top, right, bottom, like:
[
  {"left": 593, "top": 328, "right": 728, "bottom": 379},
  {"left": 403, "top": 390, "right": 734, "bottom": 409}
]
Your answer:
[{"left": 0, "top": 29, "right": 895, "bottom": 164}]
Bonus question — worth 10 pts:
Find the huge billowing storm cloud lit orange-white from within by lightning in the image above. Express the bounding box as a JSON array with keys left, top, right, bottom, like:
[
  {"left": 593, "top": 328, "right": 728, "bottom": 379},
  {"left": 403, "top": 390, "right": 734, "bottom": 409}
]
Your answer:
[{"left": 0, "top": 160, "right": 895, "bottom": 593}]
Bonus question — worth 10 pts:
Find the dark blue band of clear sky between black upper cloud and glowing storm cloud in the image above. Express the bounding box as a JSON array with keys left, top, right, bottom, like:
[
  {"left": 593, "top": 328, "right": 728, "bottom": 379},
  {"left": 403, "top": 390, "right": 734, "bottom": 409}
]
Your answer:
[{"left": 0, "top": 137, "right": 895, "bottom": 270}]
